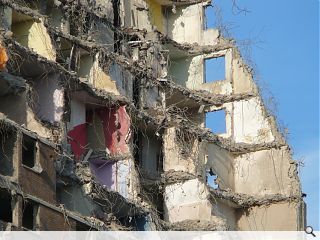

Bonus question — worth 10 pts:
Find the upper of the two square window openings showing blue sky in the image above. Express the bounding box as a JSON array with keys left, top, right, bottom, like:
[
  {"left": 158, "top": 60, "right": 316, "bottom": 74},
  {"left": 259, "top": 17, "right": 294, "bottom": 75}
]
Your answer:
[{"left": 204, "top": 56, "right": 226, "bottom": 83}]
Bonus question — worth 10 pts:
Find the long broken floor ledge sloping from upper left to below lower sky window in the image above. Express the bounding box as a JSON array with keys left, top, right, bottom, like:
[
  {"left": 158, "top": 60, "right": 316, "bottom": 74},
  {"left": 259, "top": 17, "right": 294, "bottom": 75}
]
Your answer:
[{"left": 5, "top": 32, "right": 285, "bottom": 154}]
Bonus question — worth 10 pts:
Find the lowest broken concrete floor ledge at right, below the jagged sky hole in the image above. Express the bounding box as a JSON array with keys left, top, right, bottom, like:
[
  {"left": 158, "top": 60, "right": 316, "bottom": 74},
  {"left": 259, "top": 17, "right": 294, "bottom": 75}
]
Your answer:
[{"left": 210, "top": 189, "right": 302, "bottom": 208}]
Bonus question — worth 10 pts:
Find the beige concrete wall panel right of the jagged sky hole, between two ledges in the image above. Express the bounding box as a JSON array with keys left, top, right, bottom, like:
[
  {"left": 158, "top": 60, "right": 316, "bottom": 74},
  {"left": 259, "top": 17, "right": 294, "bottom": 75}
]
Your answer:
[{"left": 234, "top": 147, "right": 300, "bottom": 196}]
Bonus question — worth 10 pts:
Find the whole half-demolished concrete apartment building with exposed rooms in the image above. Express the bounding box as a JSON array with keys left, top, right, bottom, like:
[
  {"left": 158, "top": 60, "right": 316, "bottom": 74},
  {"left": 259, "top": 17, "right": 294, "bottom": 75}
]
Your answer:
[{"left": 0, "top": 0, "right": 306, "bottom": 231}]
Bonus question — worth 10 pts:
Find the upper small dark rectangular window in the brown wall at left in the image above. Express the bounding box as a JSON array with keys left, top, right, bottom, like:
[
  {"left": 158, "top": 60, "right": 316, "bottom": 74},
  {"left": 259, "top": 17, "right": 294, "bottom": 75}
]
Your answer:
[{"left": 22, "top": 134, "right": 37, "bottom": 168}]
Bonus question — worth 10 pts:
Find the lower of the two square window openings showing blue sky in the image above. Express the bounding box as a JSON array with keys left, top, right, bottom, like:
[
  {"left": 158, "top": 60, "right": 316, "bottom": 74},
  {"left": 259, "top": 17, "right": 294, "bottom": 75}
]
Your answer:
[{"left": 206, "top": 109, "right": 227, "bottom": 134}]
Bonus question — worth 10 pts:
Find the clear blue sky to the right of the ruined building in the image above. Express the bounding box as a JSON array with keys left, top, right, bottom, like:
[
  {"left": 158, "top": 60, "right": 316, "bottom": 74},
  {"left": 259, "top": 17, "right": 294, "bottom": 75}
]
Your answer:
[{"left": 208, "top": 0, "right": 320, "bottom": 230}]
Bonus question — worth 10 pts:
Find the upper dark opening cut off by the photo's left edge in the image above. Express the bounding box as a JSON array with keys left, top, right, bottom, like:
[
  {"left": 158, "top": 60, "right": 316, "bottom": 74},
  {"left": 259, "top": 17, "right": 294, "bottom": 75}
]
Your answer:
[{"left": 0, "top": 130, "right": 16, "bottom": 176}]
